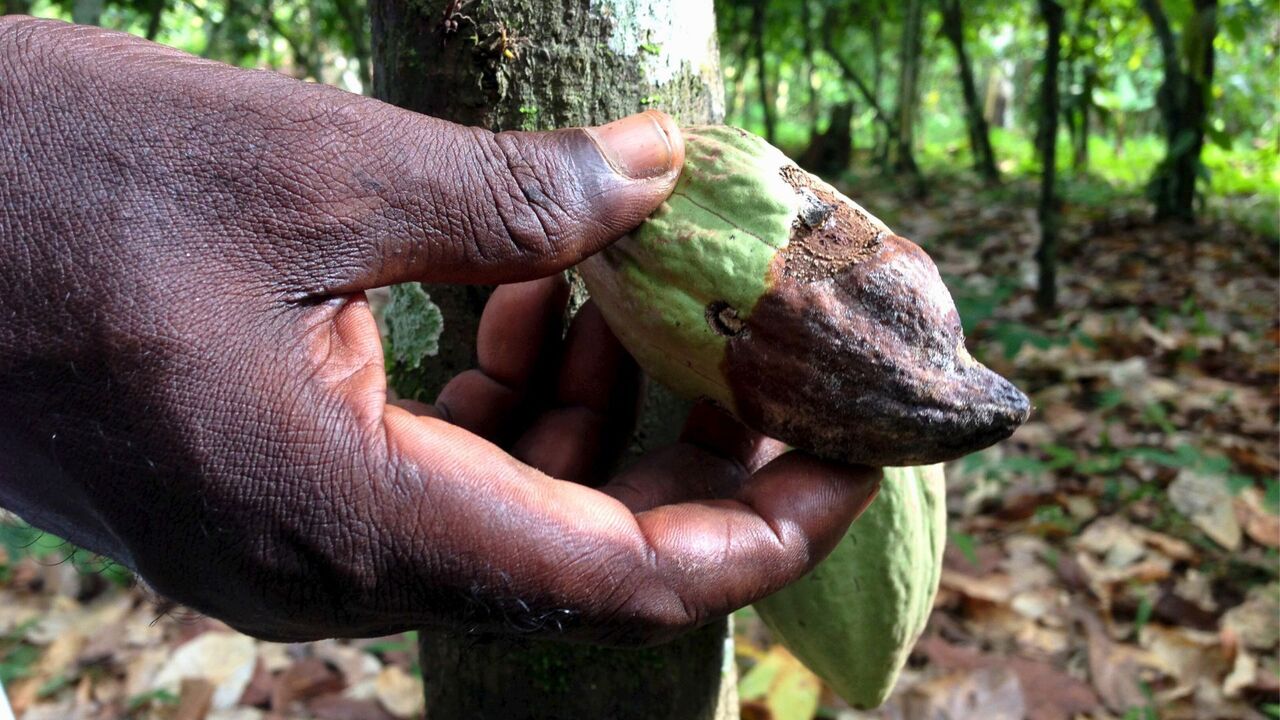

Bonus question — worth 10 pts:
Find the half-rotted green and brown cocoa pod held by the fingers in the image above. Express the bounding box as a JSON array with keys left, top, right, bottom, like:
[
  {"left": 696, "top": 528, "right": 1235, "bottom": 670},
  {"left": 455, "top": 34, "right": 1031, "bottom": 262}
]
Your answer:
[{"left": 580, "top": 126, "right": 1029, "bottom": 466}]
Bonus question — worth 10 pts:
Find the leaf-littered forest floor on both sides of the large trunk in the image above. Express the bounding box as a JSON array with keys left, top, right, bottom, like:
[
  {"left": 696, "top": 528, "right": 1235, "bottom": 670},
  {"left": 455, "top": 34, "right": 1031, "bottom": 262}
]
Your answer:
[{"left": 0, "top": 169, "right": 1280, "bottom": 720}]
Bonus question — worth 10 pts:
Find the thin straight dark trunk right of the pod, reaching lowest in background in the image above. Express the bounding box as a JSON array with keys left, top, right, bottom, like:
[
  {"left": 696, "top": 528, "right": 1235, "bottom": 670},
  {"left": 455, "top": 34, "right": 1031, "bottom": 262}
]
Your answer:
[{"left": 1036, "top": 0, "right": 1064, "bottom": 313}]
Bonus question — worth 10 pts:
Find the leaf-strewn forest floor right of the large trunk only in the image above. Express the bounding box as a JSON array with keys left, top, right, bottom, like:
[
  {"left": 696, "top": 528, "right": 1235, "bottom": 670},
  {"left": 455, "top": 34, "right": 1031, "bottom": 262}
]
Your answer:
[{"left": 737, "top": 166, "right": 1280, "bottom": 720}]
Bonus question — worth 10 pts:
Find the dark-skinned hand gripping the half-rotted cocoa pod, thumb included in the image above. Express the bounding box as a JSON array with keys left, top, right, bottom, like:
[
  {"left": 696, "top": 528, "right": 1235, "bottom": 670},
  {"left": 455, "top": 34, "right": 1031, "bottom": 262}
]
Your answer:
[{"left": 0, "top": 18, "right": 879, "bottom": 644}]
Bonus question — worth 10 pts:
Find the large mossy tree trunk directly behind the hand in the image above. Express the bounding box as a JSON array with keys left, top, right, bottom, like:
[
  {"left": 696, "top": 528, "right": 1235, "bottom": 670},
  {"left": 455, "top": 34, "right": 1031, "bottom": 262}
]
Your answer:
[{"left": 370, "top": 0, "right": 737, "bottom": 720}]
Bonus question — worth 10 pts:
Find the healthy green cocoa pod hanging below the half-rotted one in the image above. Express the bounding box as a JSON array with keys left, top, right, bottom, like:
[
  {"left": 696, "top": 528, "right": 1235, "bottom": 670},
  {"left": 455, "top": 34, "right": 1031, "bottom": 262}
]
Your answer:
[{"left": 755, "top": 465, "right": 947, "bottom": 710}]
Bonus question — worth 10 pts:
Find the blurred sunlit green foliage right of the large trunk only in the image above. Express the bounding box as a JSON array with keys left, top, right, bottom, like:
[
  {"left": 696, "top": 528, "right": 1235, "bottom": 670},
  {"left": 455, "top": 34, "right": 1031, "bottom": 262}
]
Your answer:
[{"left": 717, "top": 0, "right": 1280, "bottom": 222}]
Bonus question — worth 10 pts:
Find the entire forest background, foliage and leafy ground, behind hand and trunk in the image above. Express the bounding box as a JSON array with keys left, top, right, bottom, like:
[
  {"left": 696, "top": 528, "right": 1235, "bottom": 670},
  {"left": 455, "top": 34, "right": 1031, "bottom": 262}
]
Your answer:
[{"left": 0, "top": 0, "right": 1280, "bottom": 719}]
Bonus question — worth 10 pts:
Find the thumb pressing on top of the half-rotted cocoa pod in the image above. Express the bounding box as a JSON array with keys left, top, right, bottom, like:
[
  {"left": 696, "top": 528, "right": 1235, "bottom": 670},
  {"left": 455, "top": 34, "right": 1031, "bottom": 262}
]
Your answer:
[{"left": 301, "top": 110, "right": 685, "bottom": 292}]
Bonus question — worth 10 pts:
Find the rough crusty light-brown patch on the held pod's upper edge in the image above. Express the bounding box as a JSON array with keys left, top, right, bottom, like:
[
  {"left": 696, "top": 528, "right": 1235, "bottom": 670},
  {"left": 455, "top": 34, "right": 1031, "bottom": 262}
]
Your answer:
[{"left": 782, "top": 165, "right": 886, "bottom": 283}]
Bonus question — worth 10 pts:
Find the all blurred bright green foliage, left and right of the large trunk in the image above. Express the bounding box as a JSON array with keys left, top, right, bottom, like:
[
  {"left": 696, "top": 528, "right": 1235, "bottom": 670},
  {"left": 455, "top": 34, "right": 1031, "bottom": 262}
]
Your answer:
[{"left": 12, "top": 0, "right": 1280, "bottom": 221}]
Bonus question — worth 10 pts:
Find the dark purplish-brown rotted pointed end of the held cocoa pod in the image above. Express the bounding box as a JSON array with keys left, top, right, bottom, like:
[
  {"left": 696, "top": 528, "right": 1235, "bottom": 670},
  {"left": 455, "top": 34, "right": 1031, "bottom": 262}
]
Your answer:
[{"left": 723, "top": 233, "right": 1029, "bottom": 466}]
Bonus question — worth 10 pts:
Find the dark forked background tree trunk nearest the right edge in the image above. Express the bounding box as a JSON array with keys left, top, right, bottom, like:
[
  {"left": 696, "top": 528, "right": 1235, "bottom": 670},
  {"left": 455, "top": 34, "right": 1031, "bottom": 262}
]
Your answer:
[{"left": 1142, "top": 0, "right": 1217, "bottom": 223}]
